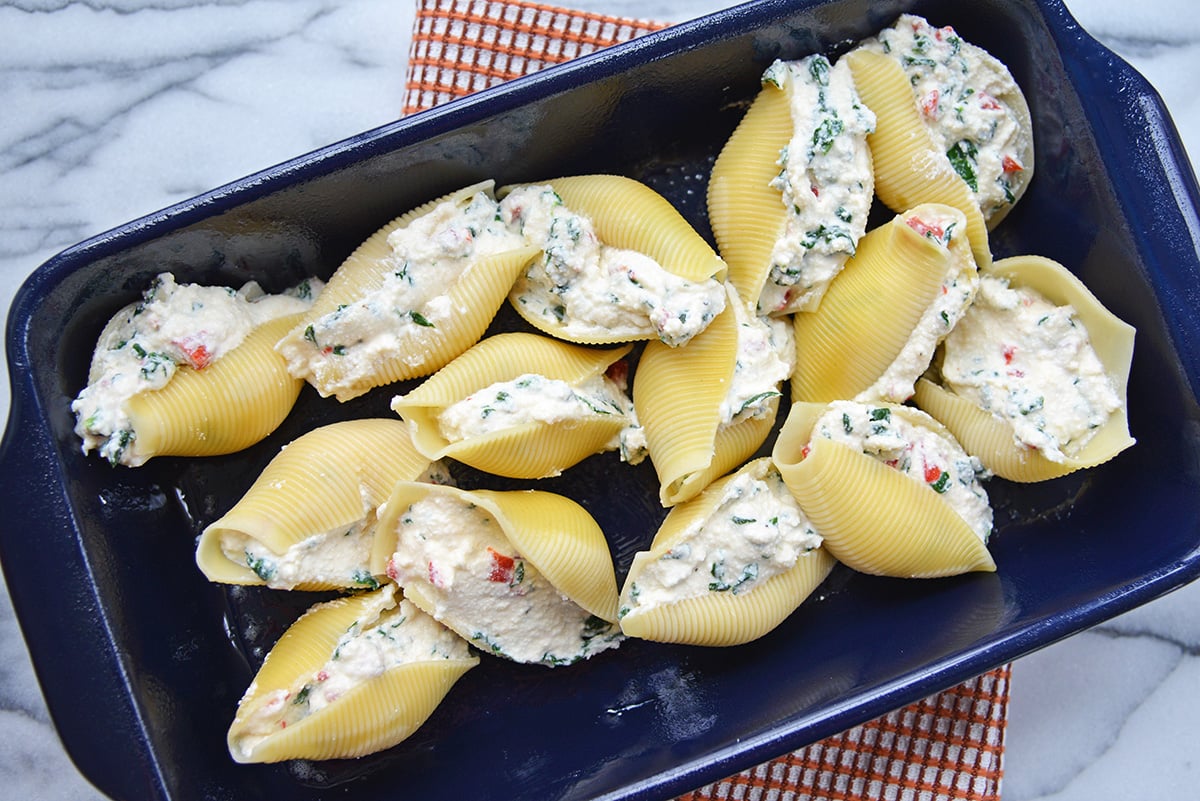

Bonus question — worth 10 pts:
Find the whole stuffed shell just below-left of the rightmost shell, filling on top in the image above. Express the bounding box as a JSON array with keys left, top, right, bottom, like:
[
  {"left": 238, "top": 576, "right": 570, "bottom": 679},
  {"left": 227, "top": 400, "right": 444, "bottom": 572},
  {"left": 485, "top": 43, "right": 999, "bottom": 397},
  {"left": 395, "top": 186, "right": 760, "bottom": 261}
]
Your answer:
[{"left": 772, "top": 401, "right": 996, "bottom": 578}]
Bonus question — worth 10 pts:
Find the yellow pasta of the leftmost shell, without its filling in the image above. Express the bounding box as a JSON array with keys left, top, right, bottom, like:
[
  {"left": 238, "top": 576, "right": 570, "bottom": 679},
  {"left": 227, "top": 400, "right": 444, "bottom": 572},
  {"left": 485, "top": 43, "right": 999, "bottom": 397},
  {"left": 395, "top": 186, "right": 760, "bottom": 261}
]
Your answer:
[{"left": 125, "top": 314, "right": 304, "bottom": 464}]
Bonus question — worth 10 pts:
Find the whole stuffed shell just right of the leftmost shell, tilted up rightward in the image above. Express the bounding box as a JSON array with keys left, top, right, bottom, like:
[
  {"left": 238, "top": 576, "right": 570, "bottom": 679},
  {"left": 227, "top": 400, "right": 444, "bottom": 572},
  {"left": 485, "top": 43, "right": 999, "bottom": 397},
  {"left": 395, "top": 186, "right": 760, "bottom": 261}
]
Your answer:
[{"left": 277, "top": 181, "right": 536, "bottom": 401}]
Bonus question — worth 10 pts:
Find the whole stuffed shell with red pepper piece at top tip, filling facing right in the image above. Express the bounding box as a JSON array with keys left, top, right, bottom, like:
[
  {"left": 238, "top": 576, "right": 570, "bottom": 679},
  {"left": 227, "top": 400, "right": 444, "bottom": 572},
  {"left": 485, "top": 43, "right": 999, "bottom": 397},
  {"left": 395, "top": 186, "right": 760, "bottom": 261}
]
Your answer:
[{"left": 792, "top": 204, "right": 979, "bottom": 403}]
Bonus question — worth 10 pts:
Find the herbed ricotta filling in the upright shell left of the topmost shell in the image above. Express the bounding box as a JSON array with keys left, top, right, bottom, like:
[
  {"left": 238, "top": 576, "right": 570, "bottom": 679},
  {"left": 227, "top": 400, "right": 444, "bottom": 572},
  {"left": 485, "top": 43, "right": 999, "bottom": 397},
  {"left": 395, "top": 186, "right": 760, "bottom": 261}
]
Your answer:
[{"left": 758, "top": 55, "right": 875, "bottom": 314}]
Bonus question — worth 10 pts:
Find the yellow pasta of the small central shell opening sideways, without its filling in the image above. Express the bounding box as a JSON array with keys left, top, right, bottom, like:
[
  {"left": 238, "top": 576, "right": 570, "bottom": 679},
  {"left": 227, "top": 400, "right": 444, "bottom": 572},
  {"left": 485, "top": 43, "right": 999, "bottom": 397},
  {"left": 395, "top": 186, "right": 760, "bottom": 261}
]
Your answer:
[{"left": 391, "top": 332, "right": 631, "bottom": 478}]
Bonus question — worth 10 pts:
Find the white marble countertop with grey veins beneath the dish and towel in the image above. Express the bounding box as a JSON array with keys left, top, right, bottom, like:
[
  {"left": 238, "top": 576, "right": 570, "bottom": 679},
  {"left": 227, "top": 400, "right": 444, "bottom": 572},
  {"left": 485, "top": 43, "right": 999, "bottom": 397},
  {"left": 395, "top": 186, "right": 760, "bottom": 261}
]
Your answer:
[{"left": 0, "top": 0, "right": 1200, "bottom": 801}]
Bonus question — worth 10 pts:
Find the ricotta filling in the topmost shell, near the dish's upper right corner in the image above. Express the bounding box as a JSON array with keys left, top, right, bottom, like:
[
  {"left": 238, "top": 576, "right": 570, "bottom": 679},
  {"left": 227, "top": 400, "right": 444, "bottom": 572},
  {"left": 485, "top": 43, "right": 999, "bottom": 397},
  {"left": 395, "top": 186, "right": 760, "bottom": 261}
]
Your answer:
[{"left": 865, "top": 14, "right": 1032, "bottom": 218}]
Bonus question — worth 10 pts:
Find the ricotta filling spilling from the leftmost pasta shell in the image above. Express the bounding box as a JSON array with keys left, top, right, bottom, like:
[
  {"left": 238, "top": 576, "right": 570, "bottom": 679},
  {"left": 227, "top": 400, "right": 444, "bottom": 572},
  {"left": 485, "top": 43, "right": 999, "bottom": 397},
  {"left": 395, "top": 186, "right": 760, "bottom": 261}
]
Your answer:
[{"left": 71, "top": 272, "right": 323, "bottom": 466}]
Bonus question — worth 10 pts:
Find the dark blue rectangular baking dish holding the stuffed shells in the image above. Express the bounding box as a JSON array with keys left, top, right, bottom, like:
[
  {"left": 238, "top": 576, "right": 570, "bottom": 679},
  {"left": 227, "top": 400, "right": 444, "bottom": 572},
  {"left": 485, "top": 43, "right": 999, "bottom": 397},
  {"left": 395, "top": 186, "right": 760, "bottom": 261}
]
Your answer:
[{"left": 0, "top": 0, "right": 1200, "bottom": 801}]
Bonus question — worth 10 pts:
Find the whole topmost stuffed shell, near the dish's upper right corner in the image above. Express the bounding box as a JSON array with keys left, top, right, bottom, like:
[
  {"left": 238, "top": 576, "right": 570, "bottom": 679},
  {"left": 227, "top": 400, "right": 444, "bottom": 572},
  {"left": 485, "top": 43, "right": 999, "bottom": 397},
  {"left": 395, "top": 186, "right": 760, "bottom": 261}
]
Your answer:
[{"left": 846, "top": 14, "right": 1033, "bottom": 266}]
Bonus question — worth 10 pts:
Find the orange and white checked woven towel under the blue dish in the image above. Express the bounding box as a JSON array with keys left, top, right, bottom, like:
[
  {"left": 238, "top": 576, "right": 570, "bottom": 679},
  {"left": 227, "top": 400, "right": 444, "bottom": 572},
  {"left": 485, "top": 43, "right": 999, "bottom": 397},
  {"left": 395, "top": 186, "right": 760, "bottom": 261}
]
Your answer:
[{"left": 404, "top": 0, "right": 1012, "bottom": 801}]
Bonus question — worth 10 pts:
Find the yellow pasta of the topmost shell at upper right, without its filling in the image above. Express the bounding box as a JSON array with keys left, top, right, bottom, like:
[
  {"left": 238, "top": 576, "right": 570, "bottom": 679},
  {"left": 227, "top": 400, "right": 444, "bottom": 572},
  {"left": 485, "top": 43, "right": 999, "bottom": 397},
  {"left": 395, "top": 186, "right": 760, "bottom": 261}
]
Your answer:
[{"left": 845, "top": 48, "right": 993, "bottom": 267}]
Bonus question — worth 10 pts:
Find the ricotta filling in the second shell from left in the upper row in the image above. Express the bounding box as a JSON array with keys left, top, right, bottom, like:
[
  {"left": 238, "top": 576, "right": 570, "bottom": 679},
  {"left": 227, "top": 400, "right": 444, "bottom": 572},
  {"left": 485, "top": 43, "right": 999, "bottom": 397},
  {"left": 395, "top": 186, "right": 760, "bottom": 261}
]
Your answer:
[{"left": 282, "top": 185, "right": 524, "bottom": 389}]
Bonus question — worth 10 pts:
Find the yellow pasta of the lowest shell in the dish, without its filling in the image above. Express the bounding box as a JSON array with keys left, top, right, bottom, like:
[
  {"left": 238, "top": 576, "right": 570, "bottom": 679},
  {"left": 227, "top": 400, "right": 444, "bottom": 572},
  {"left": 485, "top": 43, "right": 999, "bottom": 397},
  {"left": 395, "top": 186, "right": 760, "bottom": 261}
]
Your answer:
[{"left": 228, "top": 585, "right": 479, "bottom": 763}]
